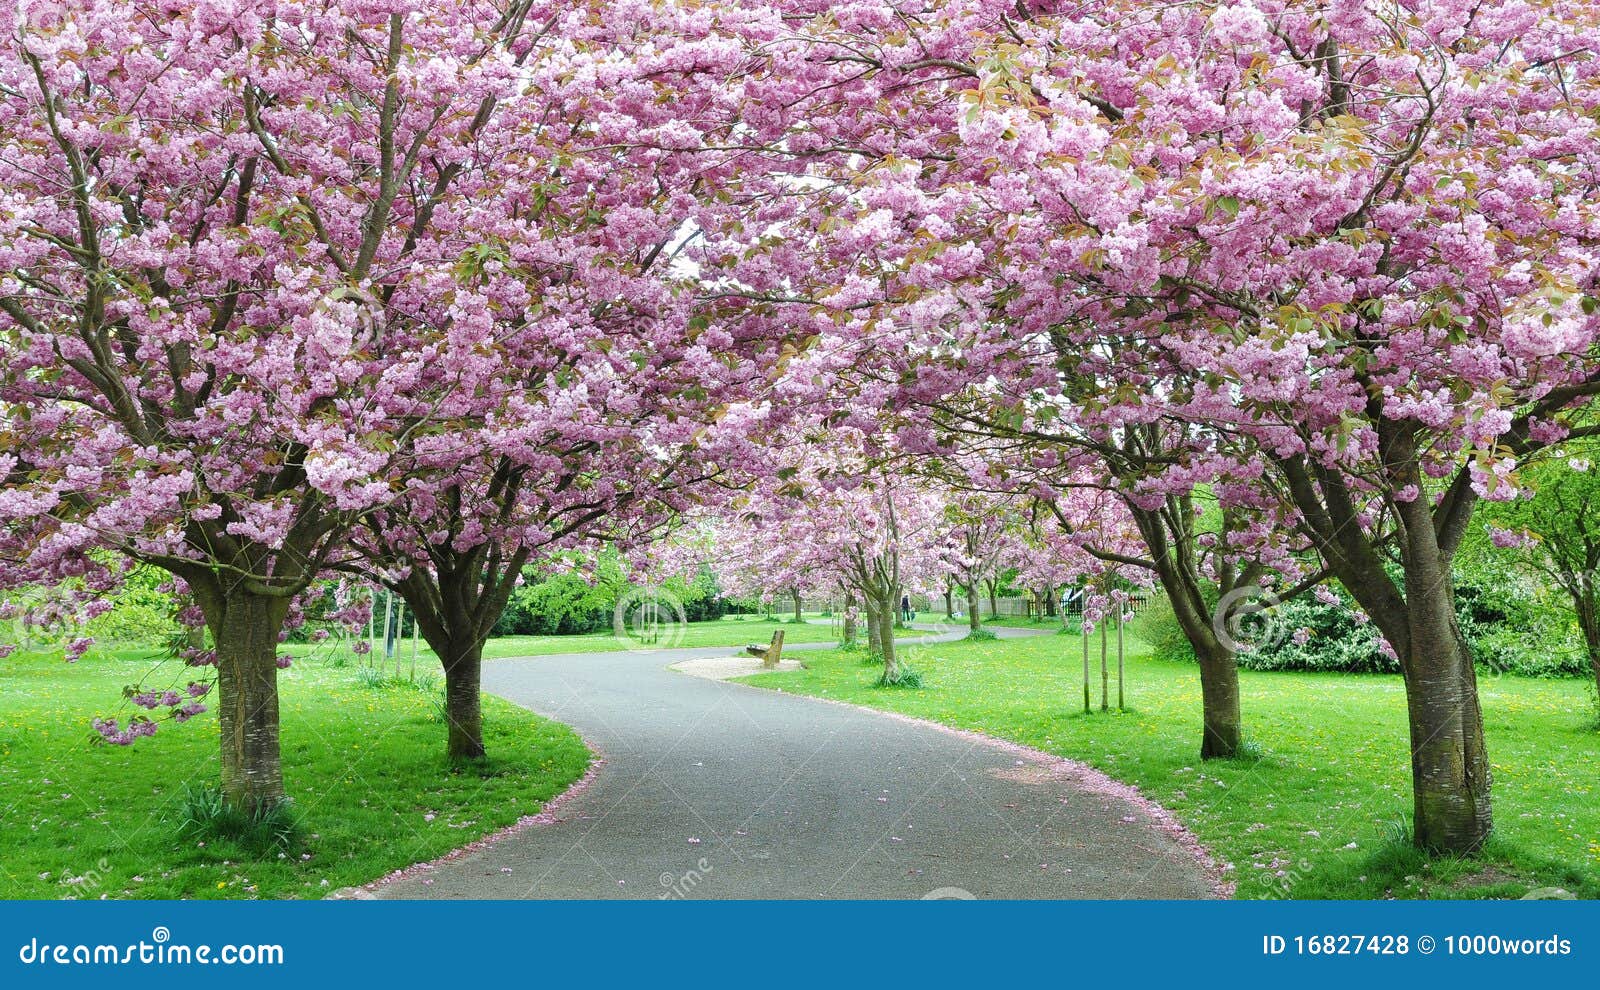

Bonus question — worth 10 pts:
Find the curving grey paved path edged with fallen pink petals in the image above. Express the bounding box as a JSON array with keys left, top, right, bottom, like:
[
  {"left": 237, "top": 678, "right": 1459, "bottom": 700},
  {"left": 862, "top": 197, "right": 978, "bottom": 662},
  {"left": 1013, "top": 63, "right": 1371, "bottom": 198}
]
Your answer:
[{"left": 371, "top": 630, "right": 1216, "bottom": 899}]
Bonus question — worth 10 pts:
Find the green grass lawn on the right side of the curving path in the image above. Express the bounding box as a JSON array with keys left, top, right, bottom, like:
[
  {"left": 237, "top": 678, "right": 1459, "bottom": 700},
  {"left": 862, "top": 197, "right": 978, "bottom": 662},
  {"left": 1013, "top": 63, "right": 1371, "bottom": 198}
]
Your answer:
[{"left": 744, "top": 635, "right": 1600, "bottom": 897}]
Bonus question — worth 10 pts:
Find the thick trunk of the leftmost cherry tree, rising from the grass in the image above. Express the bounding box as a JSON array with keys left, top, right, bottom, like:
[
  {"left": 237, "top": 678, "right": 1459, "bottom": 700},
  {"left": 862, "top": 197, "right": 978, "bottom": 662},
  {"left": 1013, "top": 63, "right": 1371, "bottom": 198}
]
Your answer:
[{"left": 208, "top": 592, "right": 290, "bottom": 814}]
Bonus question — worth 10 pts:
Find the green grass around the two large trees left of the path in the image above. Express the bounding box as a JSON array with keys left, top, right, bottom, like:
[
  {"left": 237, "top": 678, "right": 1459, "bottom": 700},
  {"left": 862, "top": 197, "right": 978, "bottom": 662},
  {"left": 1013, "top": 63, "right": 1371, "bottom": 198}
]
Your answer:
[{"left": 0, "top": 653, "right": 589, "bottom": 899}]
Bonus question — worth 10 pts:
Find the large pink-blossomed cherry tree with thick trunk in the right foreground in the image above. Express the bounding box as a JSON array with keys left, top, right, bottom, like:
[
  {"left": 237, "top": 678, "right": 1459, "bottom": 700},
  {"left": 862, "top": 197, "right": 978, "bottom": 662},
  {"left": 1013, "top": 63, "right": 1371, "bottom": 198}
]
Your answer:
[{"left": 979, "top": 3, "right": 1600, "bottom": 851}]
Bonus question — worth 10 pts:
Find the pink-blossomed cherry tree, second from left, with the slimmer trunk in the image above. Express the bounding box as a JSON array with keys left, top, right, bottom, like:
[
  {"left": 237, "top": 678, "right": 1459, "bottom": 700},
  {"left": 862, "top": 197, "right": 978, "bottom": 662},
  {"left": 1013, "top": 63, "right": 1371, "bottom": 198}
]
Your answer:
[{"left": 318, "top": 6, "right": 782, "bottom": 760}]
